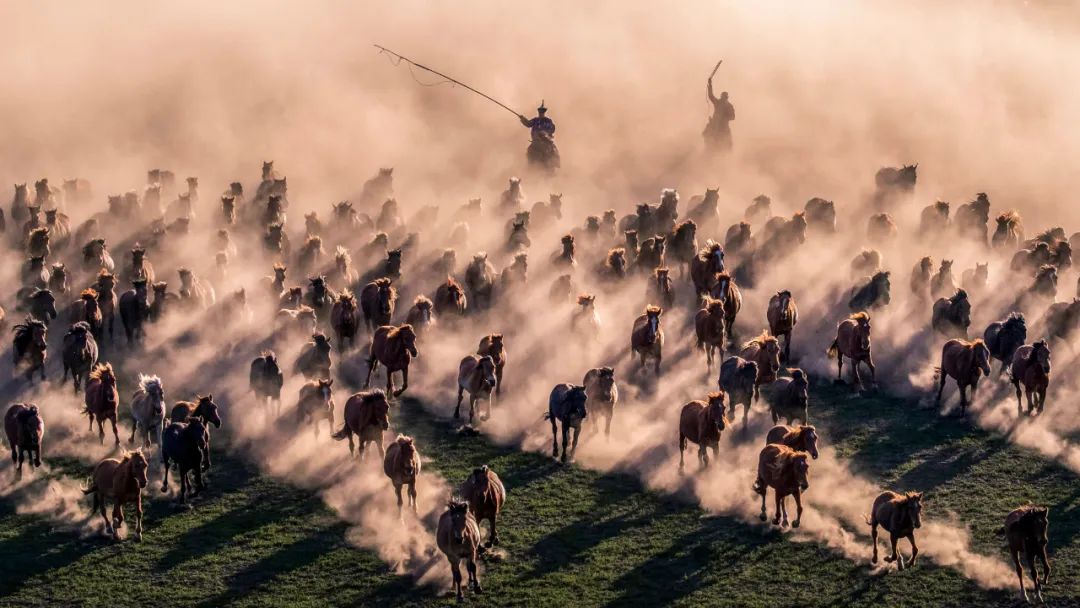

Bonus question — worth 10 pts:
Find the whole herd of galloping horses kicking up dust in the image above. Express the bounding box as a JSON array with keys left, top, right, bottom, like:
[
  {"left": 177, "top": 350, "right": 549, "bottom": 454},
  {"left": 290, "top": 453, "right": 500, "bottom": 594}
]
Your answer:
[{"left": 4, "top": 162, "right": 1058, "bottom": 598}]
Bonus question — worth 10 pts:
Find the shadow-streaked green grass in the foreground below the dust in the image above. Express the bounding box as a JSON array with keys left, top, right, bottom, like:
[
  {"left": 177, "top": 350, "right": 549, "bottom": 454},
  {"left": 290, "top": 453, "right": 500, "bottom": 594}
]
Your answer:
[{"left": 0, "top": 386, "right": 1080, "bottom": 607}]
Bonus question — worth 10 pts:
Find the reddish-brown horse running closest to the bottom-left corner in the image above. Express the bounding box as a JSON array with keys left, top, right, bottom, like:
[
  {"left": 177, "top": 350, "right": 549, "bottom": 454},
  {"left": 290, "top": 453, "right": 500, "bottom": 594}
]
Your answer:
[{"left": 82, "top": 450, "right": 149, "bottom": 541}]
